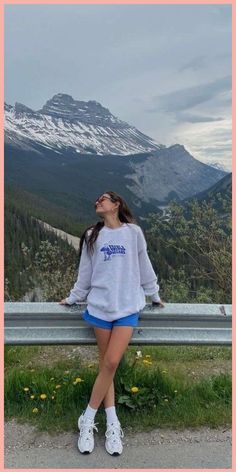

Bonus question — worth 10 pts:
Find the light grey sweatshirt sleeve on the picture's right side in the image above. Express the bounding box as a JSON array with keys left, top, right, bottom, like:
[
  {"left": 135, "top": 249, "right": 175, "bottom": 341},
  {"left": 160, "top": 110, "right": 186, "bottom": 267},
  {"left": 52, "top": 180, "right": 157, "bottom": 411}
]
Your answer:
[{"left": 138, "top": 228, "right": 160, "bottom": 302}]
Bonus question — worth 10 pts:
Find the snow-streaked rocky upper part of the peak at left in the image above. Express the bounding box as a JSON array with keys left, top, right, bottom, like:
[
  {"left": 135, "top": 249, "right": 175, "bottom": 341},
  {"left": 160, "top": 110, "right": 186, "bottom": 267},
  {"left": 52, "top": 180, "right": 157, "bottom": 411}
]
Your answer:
[{"left": 4, "top": 93, "right": 162, "bottom": 156}]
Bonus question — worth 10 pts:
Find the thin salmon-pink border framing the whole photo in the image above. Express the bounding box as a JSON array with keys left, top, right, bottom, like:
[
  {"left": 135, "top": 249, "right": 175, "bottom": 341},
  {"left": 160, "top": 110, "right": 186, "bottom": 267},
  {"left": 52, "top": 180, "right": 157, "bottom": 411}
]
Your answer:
[{"left": 0, "top": 0, "right": 236, "bottom": 472}]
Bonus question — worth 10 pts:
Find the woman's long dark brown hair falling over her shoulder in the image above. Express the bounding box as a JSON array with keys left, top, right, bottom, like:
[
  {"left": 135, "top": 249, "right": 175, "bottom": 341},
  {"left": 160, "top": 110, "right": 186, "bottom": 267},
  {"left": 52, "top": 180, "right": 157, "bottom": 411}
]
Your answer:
[{"left": 79, "top": 190, "right": 137, "bottom": 257}]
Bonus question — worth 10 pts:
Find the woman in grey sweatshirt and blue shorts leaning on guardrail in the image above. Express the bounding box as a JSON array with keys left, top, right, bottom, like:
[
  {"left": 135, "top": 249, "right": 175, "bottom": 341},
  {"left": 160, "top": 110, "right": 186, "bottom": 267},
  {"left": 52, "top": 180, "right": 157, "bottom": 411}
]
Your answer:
[{"left": 60, "top": 191, "right": 164, "bottom": 455}]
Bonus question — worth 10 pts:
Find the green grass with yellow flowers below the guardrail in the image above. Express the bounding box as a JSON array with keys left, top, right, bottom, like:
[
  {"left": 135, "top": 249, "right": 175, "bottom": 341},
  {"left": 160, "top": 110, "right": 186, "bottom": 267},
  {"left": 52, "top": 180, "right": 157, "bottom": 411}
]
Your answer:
[{"left": 5, "top": 346, "right": 231, "bottom": 433}]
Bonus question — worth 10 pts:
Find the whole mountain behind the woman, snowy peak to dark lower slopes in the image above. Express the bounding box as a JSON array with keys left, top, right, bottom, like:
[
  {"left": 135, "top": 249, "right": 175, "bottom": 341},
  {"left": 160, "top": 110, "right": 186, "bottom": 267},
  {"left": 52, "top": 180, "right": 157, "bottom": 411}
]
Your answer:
[{"left": 5, "top": 93, "right": 227, "bottom": 214}]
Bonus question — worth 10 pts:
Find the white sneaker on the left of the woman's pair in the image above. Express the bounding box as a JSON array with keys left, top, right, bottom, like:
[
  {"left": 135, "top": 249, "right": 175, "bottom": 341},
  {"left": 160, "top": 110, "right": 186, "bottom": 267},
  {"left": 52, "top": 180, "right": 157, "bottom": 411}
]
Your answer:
[{"left": 78, "top": 412, "right": 98, "bottom": 454}]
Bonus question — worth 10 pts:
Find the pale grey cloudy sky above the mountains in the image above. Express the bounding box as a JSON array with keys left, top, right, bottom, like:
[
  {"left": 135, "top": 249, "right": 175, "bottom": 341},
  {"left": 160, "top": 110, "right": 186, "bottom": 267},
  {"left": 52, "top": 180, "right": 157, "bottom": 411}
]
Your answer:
[{"left": 5, "top": 5, "right": 232, "bottom": 170}]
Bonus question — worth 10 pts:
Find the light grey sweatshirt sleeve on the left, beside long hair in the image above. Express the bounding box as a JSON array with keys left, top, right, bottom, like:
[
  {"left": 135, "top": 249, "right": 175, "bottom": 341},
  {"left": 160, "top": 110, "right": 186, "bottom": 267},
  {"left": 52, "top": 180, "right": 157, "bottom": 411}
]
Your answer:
[{"left": 66, "top": 236, "right": 92, "bottom": 305}]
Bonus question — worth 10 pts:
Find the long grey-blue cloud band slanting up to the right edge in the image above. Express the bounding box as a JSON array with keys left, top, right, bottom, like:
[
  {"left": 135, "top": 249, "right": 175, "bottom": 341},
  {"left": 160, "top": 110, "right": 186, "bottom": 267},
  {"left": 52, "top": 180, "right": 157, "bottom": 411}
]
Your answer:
[{"left": 146, "top": 76, "right": 231, "bottom": 113}]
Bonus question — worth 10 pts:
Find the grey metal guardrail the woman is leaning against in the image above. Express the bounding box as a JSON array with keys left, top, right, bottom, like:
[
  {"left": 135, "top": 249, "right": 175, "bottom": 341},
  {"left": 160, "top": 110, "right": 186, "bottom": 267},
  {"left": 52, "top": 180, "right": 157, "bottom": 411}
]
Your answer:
[{"left": 4, "top": 302, "right": 232, "bottom": 345}]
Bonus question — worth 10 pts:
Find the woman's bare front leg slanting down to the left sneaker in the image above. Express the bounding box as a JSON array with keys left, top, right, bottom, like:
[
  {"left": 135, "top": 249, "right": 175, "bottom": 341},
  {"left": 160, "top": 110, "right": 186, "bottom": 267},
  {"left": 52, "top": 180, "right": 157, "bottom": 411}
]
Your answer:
[{"left": 89, "top": 326, "right": 134, "bottom": 409}]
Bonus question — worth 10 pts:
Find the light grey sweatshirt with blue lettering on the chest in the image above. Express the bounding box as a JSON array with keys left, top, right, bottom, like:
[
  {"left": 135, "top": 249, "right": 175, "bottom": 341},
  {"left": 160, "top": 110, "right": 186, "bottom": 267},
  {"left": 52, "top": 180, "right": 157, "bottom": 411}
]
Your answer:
[{"left": 66, "top": 223, "right": 160, "bottom": 321}]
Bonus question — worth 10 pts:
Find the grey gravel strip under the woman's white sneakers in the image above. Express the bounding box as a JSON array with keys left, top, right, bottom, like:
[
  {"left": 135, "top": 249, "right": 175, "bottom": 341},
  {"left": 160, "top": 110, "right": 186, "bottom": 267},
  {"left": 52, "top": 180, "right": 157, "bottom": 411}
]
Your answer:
[{"left": 5, "top": 420, "right": 232, "bottom": 469}]
